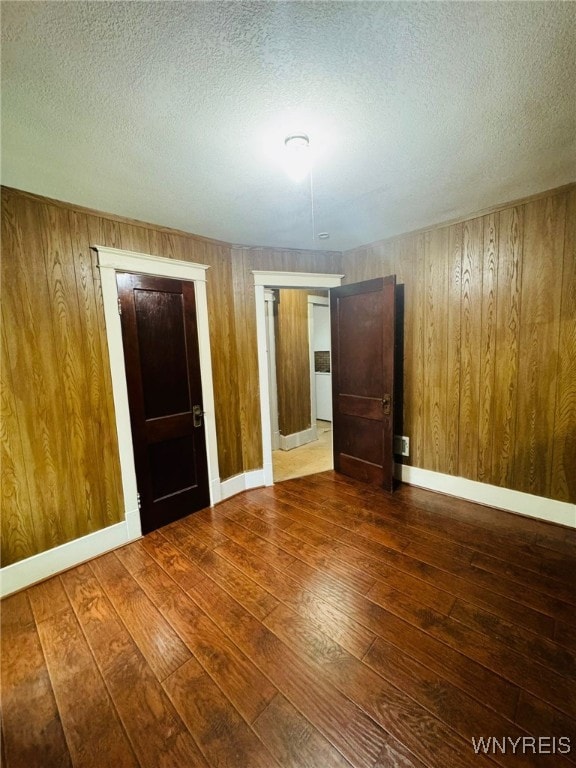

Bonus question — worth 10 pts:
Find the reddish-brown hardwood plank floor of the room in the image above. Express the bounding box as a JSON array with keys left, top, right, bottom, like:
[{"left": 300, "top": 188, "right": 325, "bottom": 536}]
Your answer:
[{"left": 2, "top": 472, "right": 576, "bottom": 768}]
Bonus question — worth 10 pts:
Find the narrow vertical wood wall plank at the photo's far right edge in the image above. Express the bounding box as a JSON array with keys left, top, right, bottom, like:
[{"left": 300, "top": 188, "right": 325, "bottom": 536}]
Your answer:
[{"left": 550, "top": 190, "right": 576, "bottom": 503}]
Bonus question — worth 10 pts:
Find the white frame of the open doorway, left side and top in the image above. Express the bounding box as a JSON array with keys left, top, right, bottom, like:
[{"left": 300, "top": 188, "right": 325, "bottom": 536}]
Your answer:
[{"left": 252, "top": 270, "right": 344, "bottom": 485}]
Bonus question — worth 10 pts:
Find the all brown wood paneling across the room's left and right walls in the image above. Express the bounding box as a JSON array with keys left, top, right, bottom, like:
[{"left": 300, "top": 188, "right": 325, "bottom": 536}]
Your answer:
[{"left": 1, "top": 187, "right": 576, "bottom": 565}]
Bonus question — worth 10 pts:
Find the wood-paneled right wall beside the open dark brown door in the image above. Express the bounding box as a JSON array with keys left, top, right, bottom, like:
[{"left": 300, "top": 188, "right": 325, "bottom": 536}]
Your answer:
[{"left": 342, "top": 187, "right": 576, "bottom": 502}]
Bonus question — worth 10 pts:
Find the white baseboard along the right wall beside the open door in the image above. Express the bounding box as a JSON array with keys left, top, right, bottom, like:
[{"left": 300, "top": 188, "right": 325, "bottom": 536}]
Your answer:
[{"left": 395, "top": 464, "right": 576, "bottom": 528}]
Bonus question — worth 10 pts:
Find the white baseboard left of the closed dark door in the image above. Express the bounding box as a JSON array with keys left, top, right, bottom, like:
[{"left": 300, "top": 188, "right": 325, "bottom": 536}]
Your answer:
[{"left": 0, "top": 510, "right": 142, "bottom": 597}]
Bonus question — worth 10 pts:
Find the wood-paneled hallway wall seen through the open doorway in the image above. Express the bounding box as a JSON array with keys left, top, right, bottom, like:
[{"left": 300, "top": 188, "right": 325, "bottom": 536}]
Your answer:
[{"left": 276, "top": 288, "right": 312, "bottom": 435}]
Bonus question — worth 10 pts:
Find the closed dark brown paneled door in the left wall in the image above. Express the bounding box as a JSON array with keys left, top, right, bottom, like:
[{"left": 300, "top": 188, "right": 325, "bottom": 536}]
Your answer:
[{"left": 116, "top": 273, "right": 210, "bottom": 533}]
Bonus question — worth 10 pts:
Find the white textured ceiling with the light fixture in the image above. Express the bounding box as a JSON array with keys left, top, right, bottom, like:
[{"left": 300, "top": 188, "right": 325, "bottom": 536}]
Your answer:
[{"left": 1, "top": 1, "right": 576, "bottom": 250}]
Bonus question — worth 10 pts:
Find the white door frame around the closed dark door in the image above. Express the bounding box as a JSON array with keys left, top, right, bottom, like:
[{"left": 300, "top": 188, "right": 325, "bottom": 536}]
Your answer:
[{"left": 92, "top": 245, "right": 221, "bottom": 538}]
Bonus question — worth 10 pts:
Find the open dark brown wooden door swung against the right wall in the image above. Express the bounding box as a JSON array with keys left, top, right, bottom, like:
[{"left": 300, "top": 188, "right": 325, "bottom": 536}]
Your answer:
[{"left": 330, "top": 276, "right": 396, "bottom": 491}]
